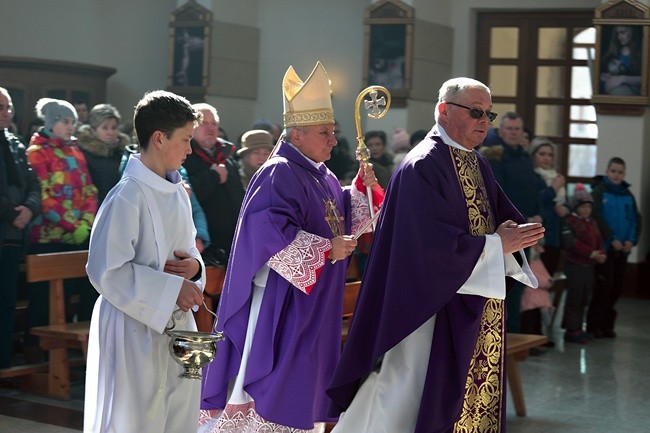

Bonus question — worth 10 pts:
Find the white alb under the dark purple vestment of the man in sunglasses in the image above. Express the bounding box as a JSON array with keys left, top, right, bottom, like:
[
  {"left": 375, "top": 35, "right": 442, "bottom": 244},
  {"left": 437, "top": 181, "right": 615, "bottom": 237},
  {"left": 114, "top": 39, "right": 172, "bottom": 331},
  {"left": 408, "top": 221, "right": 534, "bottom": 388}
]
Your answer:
[{"left": 332, "top": 234, "right": 537, "bottom": 433}]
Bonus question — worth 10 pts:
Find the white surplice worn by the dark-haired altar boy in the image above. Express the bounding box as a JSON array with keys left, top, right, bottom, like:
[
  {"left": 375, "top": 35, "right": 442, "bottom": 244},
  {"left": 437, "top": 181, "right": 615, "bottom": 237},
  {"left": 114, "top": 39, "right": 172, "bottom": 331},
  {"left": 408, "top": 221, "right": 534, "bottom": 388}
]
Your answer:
[{"left": 84, "top": 155, "right": 205, "bottom": 433}]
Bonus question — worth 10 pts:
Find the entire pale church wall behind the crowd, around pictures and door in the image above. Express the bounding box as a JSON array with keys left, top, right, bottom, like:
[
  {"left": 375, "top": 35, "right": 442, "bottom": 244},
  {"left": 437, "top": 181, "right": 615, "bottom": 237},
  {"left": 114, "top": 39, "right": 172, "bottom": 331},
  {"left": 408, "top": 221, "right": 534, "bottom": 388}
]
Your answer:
[{"left": 0, "top": 0, "right": 650, "bottom": 260}]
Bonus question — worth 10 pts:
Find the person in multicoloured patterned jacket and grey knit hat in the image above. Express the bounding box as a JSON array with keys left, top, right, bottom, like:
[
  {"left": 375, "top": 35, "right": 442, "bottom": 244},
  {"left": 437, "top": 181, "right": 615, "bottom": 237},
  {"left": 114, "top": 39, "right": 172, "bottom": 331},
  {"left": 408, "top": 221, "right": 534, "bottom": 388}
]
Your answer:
[{"left": 24, "top": 98, "right": 97, "bottom": 362}]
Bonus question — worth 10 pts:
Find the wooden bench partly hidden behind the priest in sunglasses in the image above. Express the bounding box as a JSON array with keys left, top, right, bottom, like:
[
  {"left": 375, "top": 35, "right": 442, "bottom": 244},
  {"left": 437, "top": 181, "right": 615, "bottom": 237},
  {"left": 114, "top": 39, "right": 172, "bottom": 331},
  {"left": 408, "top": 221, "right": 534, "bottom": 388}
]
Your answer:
[{"left": 341, "top": 281, "right": 548, "bottom": 416}]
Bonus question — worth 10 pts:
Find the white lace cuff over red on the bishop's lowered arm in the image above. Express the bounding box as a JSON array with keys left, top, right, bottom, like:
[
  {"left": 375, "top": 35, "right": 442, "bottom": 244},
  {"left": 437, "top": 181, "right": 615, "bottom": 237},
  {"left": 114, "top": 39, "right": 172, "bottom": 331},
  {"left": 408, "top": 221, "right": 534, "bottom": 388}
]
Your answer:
[{"left": 268, "top": 230, "right": 332, "bottom": 293}]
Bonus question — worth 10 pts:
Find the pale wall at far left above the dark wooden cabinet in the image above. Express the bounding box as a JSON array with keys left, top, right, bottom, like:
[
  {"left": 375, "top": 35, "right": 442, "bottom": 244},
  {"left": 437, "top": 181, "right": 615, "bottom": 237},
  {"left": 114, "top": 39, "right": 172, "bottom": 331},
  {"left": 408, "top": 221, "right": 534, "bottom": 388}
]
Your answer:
[{"left": 0, "top": 0, "right": 176, "bottom": 125}]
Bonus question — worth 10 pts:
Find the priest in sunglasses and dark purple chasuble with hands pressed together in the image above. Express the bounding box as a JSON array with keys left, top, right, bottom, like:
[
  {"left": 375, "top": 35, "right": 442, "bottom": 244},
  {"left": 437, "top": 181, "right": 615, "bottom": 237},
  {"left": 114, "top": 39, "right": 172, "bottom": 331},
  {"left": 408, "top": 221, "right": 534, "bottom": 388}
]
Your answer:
[{"left": 327, "top": 78, "right": 544, "bottom": 433}]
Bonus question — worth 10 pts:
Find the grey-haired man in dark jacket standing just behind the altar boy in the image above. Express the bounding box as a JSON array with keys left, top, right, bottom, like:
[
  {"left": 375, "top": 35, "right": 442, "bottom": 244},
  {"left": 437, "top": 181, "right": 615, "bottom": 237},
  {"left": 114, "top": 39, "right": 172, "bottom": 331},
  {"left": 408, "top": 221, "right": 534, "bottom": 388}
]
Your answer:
[{"left": 183, "top": 103, "right": 244, "bottom": 266}]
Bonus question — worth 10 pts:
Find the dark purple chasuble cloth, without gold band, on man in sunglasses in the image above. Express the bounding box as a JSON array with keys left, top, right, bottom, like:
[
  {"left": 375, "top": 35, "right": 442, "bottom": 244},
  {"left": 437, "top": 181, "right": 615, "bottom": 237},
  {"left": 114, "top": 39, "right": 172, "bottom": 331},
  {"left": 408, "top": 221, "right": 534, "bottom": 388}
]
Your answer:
[{"left": 327, "top": 131, "right": 525, "bottom": 433}]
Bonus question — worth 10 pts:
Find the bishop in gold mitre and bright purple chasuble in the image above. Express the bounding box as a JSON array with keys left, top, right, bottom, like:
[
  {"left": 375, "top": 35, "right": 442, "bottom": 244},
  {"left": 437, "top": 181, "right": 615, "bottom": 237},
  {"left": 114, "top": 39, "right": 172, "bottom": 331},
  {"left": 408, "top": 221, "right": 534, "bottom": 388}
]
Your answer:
[{"left": 199, "top": 63, "right": 383, "bottom": 432}]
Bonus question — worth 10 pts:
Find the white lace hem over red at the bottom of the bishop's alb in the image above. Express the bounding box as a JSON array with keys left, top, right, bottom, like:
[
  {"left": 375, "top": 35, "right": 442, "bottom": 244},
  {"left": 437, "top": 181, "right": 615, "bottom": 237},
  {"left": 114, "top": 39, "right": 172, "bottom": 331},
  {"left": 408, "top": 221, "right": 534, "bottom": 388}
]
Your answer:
[{"left": 197, "top": 402, "right": 325, "bottom": 433}]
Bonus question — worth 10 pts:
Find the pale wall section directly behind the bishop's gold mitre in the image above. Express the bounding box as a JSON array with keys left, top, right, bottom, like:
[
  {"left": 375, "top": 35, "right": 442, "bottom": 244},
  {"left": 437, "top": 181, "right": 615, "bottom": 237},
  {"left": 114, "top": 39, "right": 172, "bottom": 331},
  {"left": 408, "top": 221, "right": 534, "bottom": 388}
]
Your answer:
[{"left": 256, "top": 0, "right": 369, "bottom": 143}]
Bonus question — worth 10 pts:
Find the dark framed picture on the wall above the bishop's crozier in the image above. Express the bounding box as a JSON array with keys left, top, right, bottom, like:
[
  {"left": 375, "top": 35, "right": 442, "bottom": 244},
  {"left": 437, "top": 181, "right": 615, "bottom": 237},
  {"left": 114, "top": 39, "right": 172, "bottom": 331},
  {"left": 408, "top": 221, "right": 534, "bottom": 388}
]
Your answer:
[{"left": 362, "top": 0, "right": 415, "bottom": 107}]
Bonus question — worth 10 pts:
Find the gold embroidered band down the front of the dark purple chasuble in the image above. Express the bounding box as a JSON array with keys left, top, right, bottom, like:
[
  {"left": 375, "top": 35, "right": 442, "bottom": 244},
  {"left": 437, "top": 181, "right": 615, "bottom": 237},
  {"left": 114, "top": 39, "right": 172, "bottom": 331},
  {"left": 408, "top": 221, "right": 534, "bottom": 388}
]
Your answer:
[{"left": 449, "top": 146, "right": 506, "bottom": 433}]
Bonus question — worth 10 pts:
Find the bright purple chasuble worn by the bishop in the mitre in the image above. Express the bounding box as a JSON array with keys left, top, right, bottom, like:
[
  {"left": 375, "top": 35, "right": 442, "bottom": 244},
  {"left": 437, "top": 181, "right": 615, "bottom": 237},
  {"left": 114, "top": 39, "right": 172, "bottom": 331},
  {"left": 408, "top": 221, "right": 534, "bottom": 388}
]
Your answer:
[{"left": 201, "top": 142, "right": 351, "bottom": 429}]
